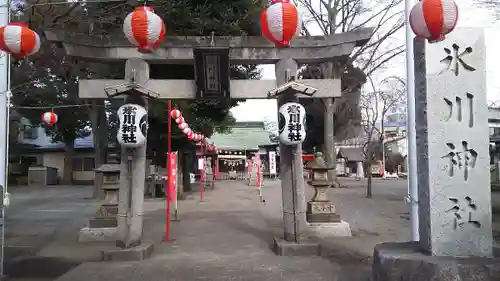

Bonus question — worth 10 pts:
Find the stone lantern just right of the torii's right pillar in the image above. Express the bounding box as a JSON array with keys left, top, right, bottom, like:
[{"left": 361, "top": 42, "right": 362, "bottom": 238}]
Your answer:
[{"left": 306, "top": 153, "right": 341, "bottom": 223}]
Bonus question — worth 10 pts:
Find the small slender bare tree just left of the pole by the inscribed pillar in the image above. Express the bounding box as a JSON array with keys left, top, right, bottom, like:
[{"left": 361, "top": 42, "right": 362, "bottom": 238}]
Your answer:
[{"left": 360, "top": 76, "right": 406, "bottom": 198}]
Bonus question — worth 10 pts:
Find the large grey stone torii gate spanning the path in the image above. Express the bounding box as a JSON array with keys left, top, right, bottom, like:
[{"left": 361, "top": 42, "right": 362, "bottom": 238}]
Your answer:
[{"left": 45, "top": 28, "right": 373, "bottom": 254}]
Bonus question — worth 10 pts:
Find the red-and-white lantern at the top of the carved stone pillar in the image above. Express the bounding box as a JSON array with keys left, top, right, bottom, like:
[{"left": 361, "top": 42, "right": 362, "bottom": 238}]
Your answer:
[{"left": 410, "top": 0, "right": 458, "bottom": 43}]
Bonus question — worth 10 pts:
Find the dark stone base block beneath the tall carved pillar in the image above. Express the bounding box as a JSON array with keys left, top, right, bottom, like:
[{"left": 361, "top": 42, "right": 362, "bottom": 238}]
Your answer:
[{"left": 372, "top": 242, "right": 500, "bottom": 281}]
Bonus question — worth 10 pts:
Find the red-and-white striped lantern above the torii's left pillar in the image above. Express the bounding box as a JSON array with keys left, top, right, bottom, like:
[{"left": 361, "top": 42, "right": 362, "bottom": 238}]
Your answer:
[{"left": 123, "top": 6, "right": 165, "bottom": 53}]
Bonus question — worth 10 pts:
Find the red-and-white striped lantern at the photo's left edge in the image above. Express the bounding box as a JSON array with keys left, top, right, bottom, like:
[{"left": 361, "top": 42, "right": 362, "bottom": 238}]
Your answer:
[{"left": 0, "top": 22, "right": 40, "bottom": 59}]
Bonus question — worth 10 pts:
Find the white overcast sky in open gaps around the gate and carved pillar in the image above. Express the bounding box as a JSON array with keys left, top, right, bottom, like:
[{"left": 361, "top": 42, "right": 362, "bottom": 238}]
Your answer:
[{"left": 231, "top": 0, "right": 500, "bottom": 121}]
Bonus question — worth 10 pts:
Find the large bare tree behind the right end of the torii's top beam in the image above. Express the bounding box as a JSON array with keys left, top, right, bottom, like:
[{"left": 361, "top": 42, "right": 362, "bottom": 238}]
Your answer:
[{"left": 297, "top": 0, "right": 404, "bottom": 185}]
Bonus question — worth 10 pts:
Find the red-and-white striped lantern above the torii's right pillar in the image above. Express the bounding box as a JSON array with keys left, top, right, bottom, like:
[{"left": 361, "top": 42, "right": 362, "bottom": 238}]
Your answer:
[{"left": 260, "top": 0, "right": 302, "bottom": 47}]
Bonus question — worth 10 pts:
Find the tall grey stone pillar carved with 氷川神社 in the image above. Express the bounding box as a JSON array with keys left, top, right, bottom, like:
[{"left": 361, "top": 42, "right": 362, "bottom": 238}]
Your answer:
[{"left": 415, "top": 28, "right": 492, "bottom": 256}]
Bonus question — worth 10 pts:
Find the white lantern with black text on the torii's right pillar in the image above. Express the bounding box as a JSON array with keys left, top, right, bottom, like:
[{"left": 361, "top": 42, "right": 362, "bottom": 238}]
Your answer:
[{"left": 278, "top": 102, "right": 306, "bottom": 145}]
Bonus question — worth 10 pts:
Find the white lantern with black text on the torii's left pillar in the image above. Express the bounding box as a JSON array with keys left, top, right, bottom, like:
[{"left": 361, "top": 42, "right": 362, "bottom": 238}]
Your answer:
[{"left": 116, "top": 104, "right": 148, "bottom": 148}]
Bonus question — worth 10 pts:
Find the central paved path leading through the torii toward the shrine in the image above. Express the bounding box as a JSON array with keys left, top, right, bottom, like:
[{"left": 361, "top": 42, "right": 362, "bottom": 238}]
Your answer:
[{"left": 53, "top": 179, "right": 368, "bottom": 281}]
